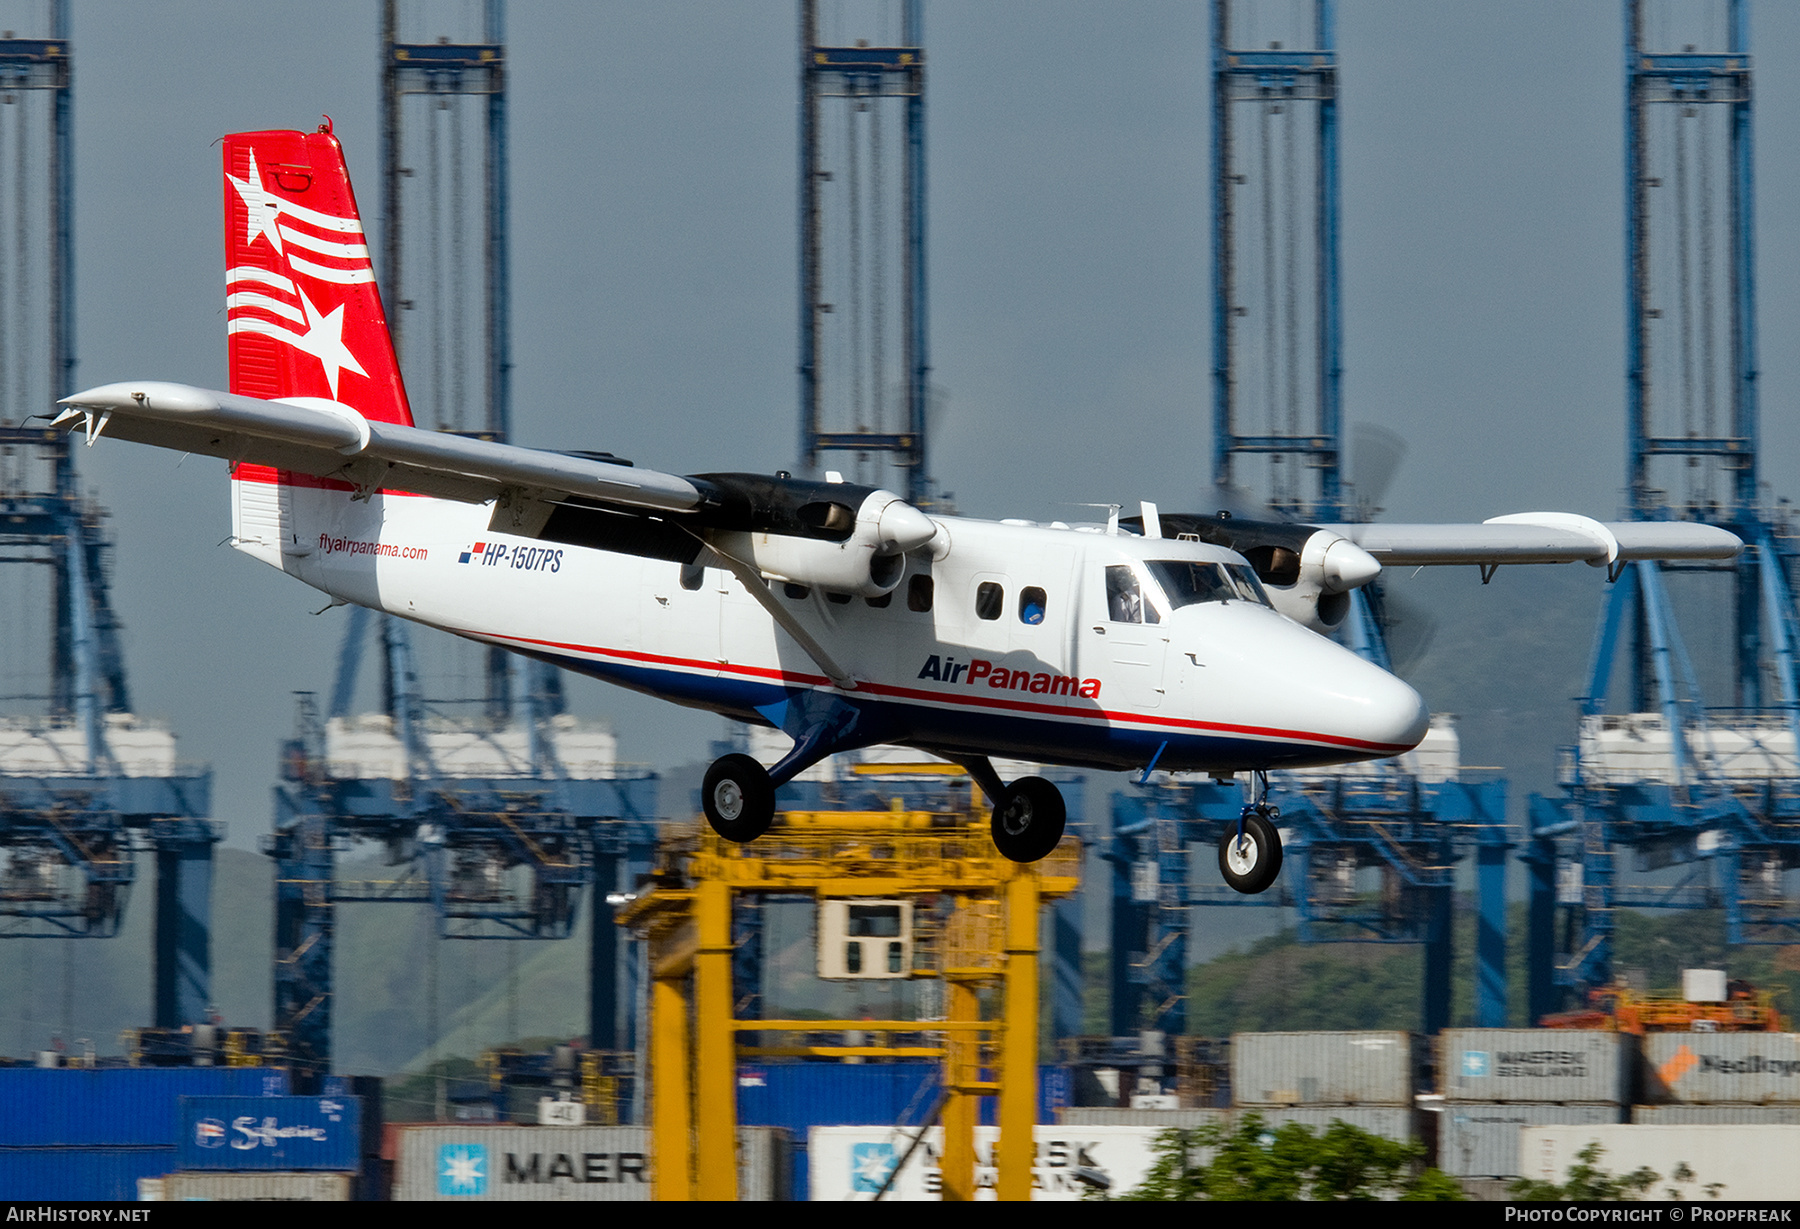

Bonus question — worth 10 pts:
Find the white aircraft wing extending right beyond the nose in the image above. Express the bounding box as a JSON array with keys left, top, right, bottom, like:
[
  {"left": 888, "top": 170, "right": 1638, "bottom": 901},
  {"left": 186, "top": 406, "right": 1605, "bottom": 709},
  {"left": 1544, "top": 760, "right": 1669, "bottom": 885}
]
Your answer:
[{"left": 1319, "top": 513, "right": 1744, "bottom": 567}]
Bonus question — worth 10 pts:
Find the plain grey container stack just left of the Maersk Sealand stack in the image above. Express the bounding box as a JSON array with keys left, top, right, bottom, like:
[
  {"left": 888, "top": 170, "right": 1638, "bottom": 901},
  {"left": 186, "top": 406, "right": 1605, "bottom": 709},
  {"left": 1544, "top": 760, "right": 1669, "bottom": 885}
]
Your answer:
[{"left": 1231, "top": 1033, "right": 1418, "bottom": 1143}]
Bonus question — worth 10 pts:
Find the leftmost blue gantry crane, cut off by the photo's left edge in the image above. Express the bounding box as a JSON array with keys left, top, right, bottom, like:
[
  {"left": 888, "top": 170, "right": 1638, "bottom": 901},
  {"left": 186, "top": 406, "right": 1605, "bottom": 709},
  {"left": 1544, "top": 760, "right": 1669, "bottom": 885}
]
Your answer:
[{"left": 0, "top": 0, "right": 220, "bottom": 1040}]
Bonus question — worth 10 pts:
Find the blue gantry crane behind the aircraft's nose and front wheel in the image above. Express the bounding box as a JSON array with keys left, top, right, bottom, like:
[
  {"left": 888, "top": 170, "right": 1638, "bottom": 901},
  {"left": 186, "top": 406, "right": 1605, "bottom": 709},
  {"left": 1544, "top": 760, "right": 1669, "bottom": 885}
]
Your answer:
[{"left": 1105, "top": 0, "right": 1510, "bottom": 1036}]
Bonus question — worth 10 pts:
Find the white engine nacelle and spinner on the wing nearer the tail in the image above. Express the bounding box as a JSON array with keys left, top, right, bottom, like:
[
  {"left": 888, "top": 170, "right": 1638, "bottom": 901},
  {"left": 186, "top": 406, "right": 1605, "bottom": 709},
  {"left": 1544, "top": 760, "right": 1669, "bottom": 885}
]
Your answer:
[{"left": 707, "top": 488, "right": 938, "bottom": 597}]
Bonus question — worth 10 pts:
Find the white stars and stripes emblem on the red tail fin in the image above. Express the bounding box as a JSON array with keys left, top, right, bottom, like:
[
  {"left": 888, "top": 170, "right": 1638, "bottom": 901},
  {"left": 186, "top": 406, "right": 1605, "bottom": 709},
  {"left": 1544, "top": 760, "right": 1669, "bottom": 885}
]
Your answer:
[{"left": 225, "top": 149, "right": 374, "bottom": 398}]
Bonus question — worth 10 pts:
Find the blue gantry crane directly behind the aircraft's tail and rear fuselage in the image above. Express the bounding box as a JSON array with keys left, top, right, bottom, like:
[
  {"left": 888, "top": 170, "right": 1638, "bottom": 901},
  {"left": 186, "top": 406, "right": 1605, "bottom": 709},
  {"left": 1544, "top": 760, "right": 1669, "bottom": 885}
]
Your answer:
[{"left": 265, "top": 0, "right": 657, "bottom": 1067}]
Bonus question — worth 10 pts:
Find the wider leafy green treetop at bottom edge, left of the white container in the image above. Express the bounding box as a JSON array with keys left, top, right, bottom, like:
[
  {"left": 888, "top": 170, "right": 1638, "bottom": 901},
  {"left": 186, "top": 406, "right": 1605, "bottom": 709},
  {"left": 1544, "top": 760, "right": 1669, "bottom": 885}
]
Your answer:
[{"left": 1121, "top": 1114, "right": 1463, "bottom": 1200}]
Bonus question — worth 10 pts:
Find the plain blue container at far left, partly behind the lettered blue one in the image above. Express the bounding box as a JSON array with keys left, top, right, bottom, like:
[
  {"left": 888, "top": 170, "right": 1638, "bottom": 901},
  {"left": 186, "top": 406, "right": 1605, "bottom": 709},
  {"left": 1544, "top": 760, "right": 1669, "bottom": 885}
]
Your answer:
[{"left": 0, "top": 1067, "right": 288, "bottom": 1152}]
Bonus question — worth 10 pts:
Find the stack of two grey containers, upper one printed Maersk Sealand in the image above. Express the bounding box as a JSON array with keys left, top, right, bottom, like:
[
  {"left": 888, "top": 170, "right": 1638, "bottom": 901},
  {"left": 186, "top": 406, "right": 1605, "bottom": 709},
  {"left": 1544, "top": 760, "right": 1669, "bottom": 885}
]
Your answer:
[{"left": 1438, "top": 1029, "right": 1633, "bottom": 1179}]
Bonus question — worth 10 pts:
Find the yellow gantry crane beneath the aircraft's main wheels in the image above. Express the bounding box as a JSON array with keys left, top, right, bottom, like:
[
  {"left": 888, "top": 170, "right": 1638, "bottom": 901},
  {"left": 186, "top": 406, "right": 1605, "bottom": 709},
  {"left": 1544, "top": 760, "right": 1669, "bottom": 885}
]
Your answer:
[{"left": 619, "top": 763, "right": 1080, "bottom": 1200}]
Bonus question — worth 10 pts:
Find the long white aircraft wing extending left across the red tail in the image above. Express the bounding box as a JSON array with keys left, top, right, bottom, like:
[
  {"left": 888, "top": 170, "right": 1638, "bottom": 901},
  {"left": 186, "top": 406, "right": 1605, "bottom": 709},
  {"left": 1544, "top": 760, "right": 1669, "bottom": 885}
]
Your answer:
[{"left": 58, "top": 381, "right": 706, "bottom": 513}]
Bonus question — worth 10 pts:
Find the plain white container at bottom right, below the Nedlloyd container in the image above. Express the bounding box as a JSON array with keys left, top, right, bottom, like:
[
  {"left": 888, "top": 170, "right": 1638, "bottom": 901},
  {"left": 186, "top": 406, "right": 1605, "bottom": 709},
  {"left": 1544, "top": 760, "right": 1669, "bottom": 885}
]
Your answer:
[{"left": 1519, "top": 1125, "right": 1800, "bottom": 1220}]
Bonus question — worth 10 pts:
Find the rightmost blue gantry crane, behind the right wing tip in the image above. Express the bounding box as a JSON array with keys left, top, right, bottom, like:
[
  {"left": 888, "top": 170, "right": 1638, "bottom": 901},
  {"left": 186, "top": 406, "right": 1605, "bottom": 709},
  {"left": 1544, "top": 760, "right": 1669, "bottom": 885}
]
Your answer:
[{"left": 1526, "top": 0, "right": 1800, "bottom": 1018}]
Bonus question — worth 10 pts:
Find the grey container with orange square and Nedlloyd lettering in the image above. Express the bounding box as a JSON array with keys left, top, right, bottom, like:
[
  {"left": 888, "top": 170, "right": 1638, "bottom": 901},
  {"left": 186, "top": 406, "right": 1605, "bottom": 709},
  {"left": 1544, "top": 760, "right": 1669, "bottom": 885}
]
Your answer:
[{"left": 1631, "top": 1033, "right": 1800, "bottom": 1126}]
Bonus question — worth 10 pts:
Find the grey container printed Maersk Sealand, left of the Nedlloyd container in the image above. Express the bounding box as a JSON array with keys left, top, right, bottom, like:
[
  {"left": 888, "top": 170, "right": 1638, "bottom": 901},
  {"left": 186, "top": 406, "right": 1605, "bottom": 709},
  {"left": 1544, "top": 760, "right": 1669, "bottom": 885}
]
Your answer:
[{"left": 1438, "top": 1029, "right": 1634, "bottom": 1105}]
